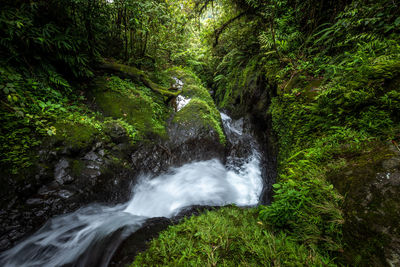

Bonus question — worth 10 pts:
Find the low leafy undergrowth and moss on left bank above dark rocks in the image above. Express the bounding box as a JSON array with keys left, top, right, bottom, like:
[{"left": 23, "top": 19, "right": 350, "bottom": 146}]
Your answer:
[{"left": 0, "top": 67, "right": 167, "bottom": 174}]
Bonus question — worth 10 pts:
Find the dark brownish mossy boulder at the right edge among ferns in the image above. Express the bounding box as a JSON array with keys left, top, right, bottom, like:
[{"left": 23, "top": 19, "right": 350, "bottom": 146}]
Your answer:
[{"left": 329, "top": 142, "right": 400, "bottom": 266}]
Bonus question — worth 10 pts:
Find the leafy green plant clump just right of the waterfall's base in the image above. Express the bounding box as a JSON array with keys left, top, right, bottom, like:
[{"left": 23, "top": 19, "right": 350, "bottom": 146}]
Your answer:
[{"left": 260, "top": 175, "right": 343, "bottom": 253}]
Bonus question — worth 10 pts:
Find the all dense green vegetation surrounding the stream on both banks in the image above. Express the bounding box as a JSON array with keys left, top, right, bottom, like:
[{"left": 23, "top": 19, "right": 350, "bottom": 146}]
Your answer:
[{"left": 0, "top": 0, "right": 400, "bottom": 266}]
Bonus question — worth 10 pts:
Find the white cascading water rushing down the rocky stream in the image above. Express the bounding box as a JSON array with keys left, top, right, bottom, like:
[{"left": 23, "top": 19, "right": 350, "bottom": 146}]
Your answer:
[{"left": 0, "top": 113, "right": 262, "bottom": 267}]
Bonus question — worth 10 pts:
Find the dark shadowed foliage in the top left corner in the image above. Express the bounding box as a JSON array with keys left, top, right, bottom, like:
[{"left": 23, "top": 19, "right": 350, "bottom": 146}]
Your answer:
[{"left": 0, "top": 1, "right": 98, "bottom": 79}]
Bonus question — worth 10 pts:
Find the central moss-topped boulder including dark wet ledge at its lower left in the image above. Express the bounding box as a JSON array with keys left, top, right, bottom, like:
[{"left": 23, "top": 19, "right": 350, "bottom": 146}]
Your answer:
[{"left": 131, "top": 68, "right": 226, "bottom": 174}]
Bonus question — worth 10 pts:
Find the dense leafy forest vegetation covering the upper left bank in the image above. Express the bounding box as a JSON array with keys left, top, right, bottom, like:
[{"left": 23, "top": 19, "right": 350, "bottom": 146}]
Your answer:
[{"left": 0, "top": 0, "right": 197, "bottom": 174}]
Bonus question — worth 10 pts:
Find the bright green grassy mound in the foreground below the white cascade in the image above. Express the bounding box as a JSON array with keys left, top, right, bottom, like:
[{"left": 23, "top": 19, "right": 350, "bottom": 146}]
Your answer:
[{"left": 131, "top": 207, "right": 332, "bottom": 266}]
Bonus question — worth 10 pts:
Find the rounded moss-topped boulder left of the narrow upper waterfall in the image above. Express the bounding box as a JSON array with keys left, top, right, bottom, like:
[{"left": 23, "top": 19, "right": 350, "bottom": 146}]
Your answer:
[{"left": 161, "top": 68, "right": 226, "bottom": 163}]
